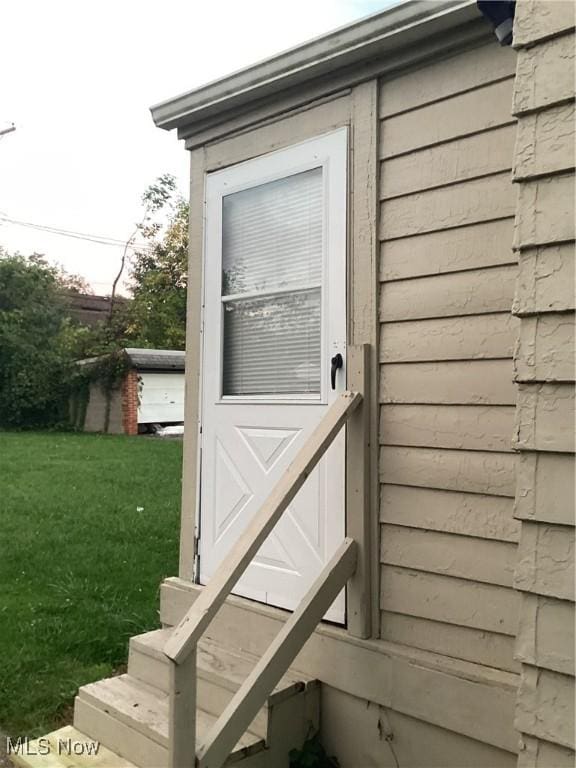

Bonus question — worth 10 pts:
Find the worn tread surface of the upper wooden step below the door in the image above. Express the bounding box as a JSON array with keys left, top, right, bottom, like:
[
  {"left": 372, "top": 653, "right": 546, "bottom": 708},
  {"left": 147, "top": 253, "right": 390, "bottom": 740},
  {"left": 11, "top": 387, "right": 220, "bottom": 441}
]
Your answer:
[{"left": 130, "top": 629, "right": 309, "bottom": 698}]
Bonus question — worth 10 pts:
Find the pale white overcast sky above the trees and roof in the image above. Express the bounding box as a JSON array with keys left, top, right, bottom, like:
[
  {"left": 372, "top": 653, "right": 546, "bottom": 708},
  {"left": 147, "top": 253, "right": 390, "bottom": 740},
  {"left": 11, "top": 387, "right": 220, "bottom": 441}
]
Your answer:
[{"left": 0, "top": 0, "right": 393, "bottom": 294}]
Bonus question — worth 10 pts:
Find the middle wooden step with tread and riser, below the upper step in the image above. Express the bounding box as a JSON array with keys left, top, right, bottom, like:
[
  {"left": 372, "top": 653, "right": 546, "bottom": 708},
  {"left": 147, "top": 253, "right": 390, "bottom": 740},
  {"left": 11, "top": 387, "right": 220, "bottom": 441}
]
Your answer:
[{"left": 74, "top": 674, "right": 265, "bottom": 768}]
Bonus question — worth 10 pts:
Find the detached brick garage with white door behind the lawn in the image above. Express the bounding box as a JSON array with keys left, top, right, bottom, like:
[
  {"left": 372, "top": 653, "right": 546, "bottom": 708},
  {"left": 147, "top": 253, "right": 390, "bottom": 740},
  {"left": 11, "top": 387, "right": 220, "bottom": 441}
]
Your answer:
[{"left": 72, "top": 347, "right": 184, "bottom": 435}]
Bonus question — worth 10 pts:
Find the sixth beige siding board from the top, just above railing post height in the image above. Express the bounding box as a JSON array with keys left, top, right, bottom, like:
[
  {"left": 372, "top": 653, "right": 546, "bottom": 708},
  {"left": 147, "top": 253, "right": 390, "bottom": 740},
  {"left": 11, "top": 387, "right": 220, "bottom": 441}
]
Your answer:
[{"left": 380, "top": 265, "right": 517, "bottom": 322}]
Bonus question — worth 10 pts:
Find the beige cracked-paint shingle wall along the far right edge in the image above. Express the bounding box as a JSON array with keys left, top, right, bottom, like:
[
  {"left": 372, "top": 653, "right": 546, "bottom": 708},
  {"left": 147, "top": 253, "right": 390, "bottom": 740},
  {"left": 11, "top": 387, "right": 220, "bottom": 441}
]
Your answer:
[{"left": 514, "top": 0, "right": 575, "bottom": 768}]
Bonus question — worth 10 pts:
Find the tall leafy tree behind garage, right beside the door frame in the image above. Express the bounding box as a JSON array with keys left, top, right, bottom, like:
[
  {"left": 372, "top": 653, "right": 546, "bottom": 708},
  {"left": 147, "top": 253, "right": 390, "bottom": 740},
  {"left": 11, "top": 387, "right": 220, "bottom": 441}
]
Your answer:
[{"left": 127, "top": 174, "right": 188, "bottom": 349}]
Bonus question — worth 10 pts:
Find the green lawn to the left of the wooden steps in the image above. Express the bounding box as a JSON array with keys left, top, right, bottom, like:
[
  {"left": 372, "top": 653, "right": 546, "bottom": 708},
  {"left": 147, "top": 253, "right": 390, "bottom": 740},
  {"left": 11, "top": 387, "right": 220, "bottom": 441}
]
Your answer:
[{"left": 0, "top": 433, "right": 182, "bottom": 736}]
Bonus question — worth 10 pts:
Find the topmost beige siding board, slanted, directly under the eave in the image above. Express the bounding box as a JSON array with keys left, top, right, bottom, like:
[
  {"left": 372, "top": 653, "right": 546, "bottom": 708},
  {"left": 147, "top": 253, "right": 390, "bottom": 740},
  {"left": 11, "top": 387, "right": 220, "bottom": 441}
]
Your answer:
[{"left": 380, "top": 44, "right": 516, "bottom": 117}]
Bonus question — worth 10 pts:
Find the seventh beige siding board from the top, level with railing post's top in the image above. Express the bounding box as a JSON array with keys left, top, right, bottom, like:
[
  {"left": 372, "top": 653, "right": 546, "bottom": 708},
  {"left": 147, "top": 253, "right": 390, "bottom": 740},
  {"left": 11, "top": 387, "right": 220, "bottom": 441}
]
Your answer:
[{"left": 380, "top": 312, "right": 520, "bottom": 363}]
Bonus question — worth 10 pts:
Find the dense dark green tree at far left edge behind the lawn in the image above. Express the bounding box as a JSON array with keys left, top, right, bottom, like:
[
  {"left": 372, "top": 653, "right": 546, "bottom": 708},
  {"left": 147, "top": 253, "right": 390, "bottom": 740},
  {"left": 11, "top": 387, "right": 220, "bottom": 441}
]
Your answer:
[{"left": 0, "top": 252, "right": 81, "bottom": 427}]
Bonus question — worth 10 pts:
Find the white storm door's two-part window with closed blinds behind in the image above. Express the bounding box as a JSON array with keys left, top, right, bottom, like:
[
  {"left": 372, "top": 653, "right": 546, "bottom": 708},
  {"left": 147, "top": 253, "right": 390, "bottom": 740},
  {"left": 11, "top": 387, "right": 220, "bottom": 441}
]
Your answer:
[{"left": 222, "top": 168, "right": 323, "bottom": 395}]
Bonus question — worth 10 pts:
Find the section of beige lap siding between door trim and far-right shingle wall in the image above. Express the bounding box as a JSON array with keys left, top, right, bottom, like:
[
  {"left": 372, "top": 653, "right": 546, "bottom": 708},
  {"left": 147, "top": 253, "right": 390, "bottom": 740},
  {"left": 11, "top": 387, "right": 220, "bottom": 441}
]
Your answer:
[{"left": 379, "top": 45, "right": 520, "bottom": 672}]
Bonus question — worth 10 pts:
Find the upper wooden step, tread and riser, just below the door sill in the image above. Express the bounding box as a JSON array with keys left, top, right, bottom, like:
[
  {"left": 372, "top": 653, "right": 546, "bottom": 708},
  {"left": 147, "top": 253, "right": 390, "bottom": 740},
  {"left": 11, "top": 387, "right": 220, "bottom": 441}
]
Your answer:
[{"left": 128, "top": 629, "right": 308, "bottom": 738}]
